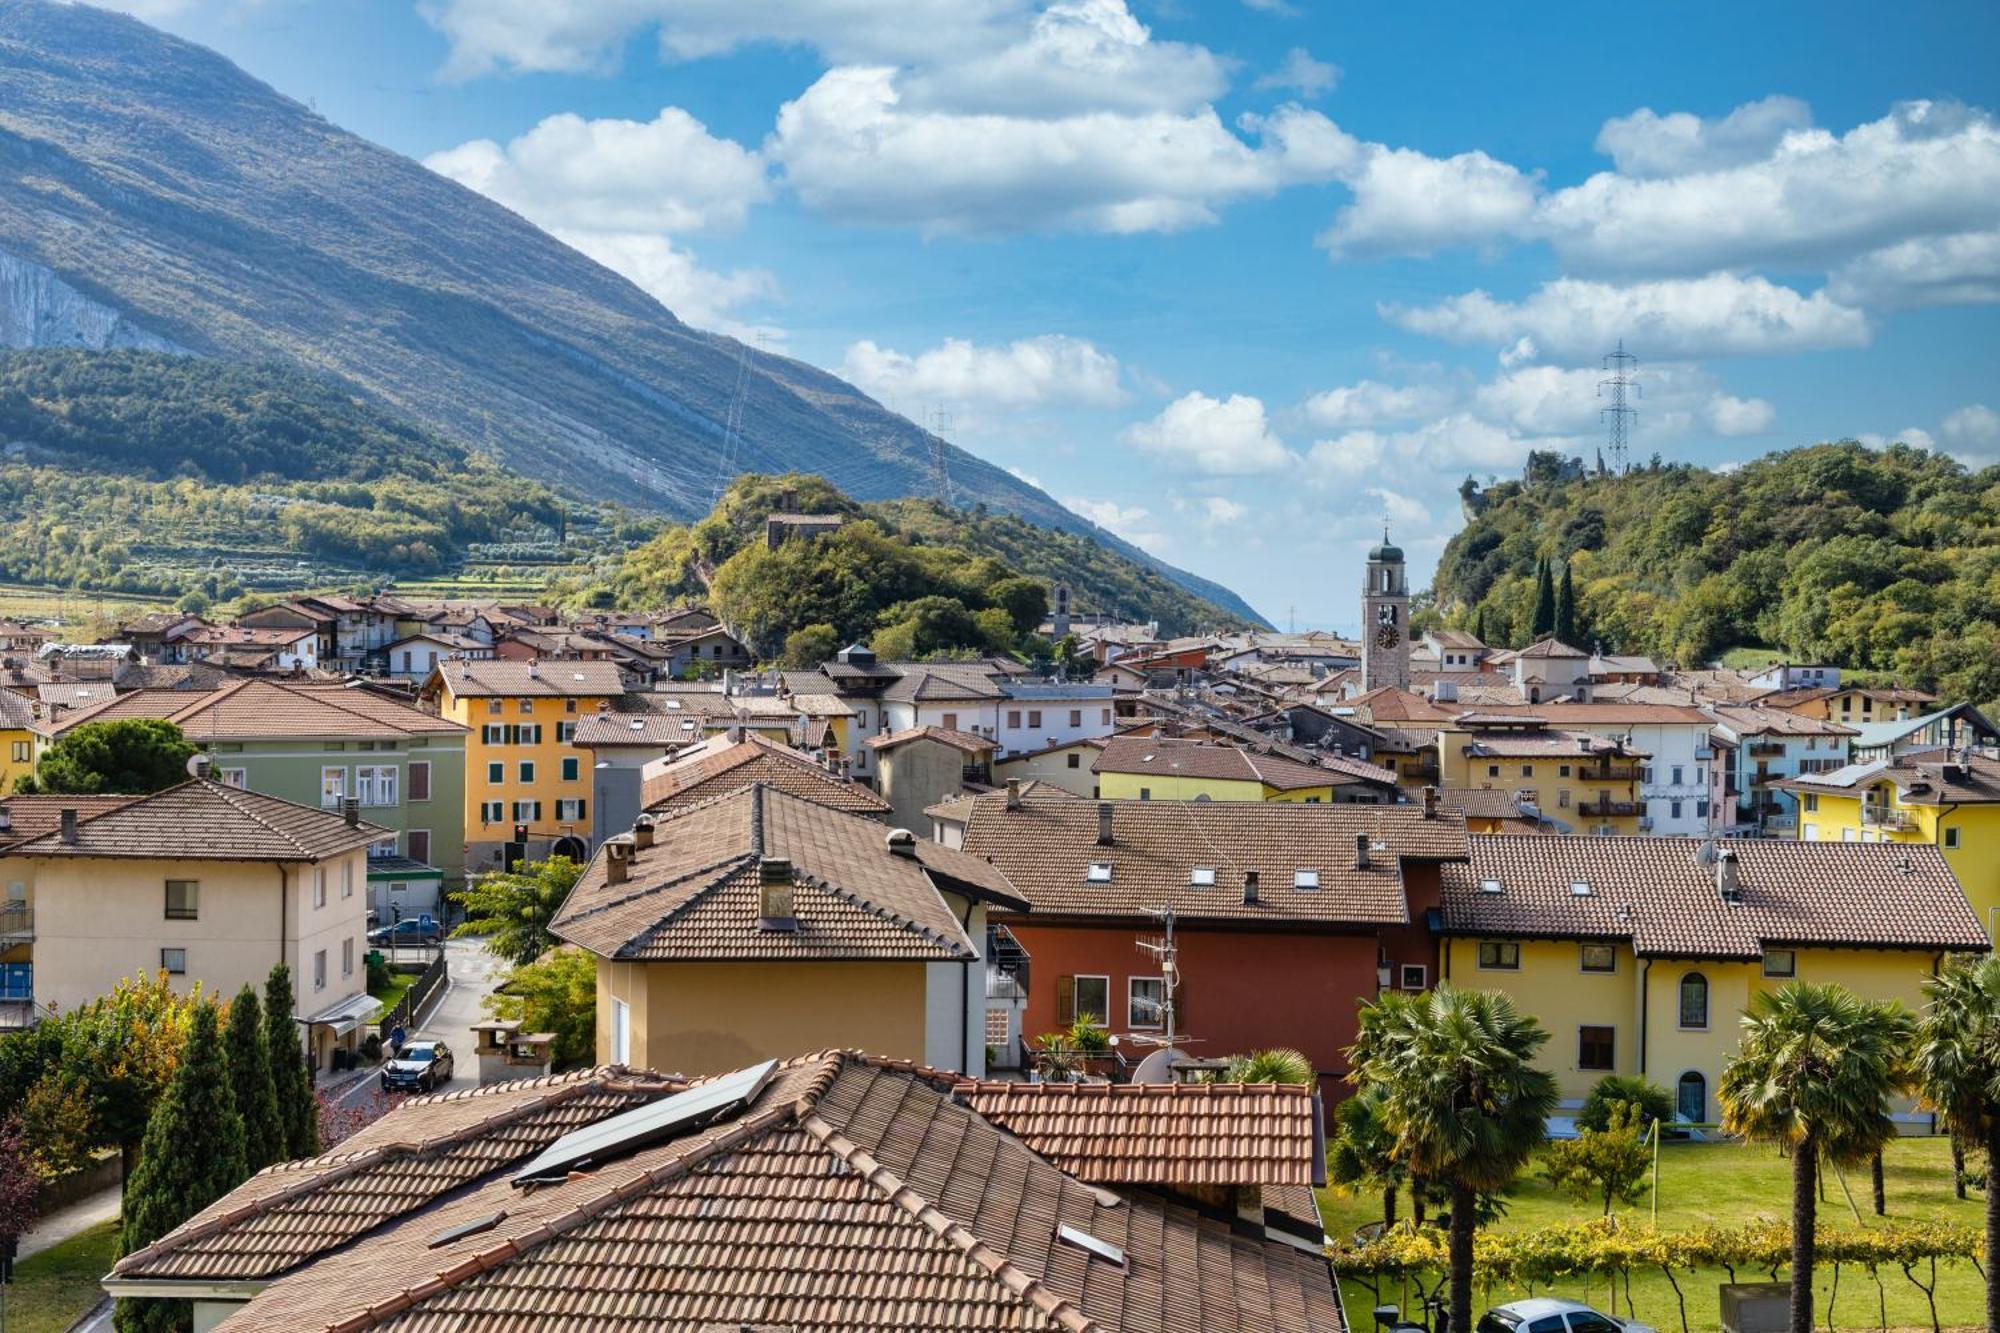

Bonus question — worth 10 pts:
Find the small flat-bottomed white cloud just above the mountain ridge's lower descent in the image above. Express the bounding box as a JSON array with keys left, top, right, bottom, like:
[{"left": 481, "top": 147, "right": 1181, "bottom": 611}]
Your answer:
[{"left": 840, "top": 334, "right": 1126, "bottom": 408}]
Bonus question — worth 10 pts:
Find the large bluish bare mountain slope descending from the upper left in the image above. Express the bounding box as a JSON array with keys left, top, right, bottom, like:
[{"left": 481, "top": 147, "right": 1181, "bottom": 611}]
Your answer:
[{"left": 0, "top": 0, "right": 1254, "bottom": 618}]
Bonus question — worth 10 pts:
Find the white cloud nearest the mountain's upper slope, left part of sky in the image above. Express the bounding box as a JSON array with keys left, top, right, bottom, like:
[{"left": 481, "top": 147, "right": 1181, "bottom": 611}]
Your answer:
[{"left": 424, "top": 106, "right": 770, "bottom": 232}]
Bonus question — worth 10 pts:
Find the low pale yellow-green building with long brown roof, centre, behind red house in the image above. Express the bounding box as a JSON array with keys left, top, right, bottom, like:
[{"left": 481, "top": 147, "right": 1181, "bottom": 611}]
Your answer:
[{"left": 1090, "top": 737, "right": 1396, "bottom": 805}]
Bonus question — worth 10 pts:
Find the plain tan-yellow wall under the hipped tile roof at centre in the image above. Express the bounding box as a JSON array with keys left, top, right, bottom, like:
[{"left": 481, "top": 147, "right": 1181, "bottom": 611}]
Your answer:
[{"left": 598, "top": 959, "right": 924, "bottom": 1075}]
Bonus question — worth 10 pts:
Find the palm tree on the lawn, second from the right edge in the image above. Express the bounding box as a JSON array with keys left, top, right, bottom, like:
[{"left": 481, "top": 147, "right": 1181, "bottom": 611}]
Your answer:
[{"left": 1716, "top": 981, "right": 1912, "bottom": 1333}]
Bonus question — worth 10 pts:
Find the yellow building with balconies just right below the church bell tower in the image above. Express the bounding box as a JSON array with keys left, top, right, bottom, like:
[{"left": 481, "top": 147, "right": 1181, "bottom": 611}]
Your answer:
[{"left": 1438, "top": 713, "right": 1648, "bottom": 835}]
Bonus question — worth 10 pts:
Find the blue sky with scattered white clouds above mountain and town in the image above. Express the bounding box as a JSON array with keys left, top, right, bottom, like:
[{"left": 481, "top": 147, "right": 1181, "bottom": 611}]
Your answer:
[{"left": 86, "top": 0, "right": 2000, "bottom": 630}]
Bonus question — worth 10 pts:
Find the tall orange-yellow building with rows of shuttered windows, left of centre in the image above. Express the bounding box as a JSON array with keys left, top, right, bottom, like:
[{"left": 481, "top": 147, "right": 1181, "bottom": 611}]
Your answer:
[{"left": 420, "top": 658, "right": 624, "bottom": 875}]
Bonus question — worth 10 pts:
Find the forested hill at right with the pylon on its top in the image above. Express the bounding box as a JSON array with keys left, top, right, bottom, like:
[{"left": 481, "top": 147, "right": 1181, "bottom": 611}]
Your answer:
[{"left": 1430, "top": 440, "right": 2000, "bottom": 701}]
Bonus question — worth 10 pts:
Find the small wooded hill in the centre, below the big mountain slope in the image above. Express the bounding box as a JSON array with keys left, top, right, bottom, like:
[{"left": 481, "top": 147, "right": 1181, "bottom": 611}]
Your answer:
[{"left": 558, "top": 472, "right": 1242, "bottom": 656}]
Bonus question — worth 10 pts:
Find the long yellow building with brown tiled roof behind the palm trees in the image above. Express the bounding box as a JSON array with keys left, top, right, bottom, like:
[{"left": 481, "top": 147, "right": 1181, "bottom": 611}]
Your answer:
[{"left": 1440, "top": 837, "right": 1988, "bottom": 1129}]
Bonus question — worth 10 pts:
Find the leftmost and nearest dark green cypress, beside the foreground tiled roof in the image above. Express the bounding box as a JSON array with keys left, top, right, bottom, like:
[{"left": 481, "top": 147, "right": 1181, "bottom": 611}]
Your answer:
[{"left": 116, "top": 1001, "right": 250, "bottom": 1333}]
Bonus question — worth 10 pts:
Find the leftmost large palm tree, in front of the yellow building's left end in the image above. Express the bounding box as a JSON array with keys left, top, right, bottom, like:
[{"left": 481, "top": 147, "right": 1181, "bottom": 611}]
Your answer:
[{"left": 1348, "top": 985, "right": 1556, "bottom": 1329}]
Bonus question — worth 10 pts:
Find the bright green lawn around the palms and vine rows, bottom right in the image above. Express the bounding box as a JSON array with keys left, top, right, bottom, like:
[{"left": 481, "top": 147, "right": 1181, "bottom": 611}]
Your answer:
[{"left": 1320, "top": 1139, "right": 1986, "bottom": 1333}]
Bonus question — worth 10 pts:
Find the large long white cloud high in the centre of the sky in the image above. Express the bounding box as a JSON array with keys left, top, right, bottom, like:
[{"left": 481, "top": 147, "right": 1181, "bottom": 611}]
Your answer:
[{"left": 766, "top": 68, "right": 1350, "bottom": 232}]
